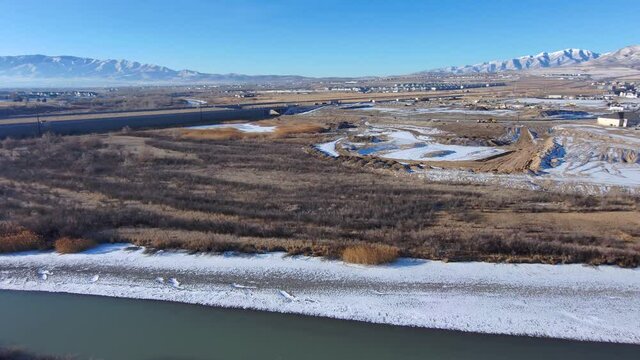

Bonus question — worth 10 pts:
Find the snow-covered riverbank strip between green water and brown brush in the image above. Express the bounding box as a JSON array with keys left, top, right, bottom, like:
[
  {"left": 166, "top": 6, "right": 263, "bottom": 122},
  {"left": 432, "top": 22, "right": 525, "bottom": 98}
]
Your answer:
[{"left": 0, "top": 245, "right": 640, "bottom": 344}]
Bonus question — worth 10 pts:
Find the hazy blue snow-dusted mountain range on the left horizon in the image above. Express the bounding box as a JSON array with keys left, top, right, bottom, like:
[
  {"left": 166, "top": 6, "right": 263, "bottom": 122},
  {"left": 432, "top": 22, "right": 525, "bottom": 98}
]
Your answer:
[{"left": 0, "top": 55, "right": 304, "bottom": 85}]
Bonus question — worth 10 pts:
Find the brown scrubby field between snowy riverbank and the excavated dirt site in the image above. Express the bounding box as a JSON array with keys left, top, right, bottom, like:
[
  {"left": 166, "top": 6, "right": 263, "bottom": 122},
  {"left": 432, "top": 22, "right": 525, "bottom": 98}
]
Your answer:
[{"left": 0, "top": 119, "right": 640, "bottom": 266}]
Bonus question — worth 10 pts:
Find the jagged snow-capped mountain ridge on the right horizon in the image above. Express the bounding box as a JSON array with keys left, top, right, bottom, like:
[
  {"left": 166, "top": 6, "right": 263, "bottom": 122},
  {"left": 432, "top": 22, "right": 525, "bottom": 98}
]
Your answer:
[{"left": 429, "top": 49, "right": 600, "bottom": 74}]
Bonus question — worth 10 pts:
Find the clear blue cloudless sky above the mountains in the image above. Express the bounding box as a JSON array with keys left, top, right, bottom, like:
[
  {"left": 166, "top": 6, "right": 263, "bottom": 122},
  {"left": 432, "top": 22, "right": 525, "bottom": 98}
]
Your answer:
[{"left": 0, "top": 0, "right": 640, "bottom": 76}]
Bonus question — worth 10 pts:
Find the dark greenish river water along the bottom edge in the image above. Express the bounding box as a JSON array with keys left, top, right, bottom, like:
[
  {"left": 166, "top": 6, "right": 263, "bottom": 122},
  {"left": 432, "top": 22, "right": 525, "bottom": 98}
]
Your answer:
[{"left": 0, "top": 291, "right": 640, "bottom": 360}]
